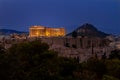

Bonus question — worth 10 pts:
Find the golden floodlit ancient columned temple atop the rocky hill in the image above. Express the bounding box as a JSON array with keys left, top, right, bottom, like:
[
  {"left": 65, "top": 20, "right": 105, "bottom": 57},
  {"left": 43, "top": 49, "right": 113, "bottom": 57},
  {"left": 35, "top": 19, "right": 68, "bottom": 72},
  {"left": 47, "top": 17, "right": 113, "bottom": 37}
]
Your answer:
[{"left": 29, "top": 26, "right": 65, "bottom": 37}]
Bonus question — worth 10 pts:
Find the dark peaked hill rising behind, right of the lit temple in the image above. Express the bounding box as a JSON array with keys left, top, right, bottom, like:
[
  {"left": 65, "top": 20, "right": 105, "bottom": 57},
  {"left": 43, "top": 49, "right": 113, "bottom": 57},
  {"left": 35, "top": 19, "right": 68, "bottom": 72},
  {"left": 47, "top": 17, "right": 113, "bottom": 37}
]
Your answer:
[{"left": 66, "top": 23, "right": 109, "bottom": 37}]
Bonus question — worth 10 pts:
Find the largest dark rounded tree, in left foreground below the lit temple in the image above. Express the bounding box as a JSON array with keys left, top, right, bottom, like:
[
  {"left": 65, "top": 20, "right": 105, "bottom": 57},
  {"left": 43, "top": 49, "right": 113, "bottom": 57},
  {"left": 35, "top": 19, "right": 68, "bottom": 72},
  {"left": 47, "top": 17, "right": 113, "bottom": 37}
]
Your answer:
[{"left": 7, "top": 41, "right": 57, "bottom": 80}]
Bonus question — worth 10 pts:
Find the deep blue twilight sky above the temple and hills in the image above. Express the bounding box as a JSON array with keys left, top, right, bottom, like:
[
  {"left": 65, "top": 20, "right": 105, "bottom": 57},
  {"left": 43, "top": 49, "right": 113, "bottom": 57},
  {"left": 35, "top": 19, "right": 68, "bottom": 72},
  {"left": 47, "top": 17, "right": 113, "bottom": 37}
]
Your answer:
[{"left": 0, "top": 0, "right": 120, "bottom": 34}]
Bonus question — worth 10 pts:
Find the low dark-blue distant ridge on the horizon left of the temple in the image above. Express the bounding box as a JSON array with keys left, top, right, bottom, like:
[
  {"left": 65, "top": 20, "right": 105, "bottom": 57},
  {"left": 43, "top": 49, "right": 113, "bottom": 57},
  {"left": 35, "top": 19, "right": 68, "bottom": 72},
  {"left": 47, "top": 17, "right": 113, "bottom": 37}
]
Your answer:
[{"left": 0, "top": 29, "right": 28, "bottom": 35}]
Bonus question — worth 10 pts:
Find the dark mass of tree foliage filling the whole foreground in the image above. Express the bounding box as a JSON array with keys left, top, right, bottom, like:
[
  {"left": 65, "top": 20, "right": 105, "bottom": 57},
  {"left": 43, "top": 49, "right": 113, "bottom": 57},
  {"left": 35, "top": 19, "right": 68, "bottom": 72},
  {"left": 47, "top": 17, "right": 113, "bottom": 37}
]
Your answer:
[{"left": 0, "top": 41, "right": 120, "bottom": 80}]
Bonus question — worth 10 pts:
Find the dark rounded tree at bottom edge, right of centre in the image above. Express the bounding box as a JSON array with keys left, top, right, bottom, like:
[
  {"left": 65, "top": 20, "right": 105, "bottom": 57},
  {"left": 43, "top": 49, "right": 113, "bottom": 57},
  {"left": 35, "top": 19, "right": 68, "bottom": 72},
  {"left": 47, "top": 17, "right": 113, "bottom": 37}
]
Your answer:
[{"left": 82, "top": 58, "right": 106, "bottom": 80}]
